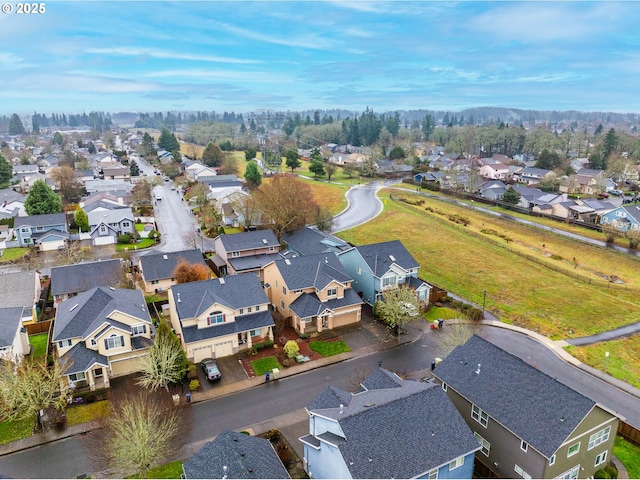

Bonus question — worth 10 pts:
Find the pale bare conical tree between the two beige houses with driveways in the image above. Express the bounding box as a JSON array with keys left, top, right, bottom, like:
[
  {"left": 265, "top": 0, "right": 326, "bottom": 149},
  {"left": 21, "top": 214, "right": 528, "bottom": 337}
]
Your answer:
[{"left": 137, "top": 322, "right": 187, "bottom": 392}]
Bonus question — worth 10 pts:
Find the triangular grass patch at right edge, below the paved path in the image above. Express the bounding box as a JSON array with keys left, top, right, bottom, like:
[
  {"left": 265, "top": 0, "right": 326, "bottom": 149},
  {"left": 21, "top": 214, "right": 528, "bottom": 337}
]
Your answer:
[{"left": 566, "top": 334, "right": 640, "bottom": 388}]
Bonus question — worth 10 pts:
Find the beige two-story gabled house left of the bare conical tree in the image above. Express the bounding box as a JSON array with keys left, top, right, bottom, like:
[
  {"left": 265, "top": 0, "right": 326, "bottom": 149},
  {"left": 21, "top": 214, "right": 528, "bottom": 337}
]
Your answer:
[{"left": 51, "top": 287, "right": 153, "bottom": 390}]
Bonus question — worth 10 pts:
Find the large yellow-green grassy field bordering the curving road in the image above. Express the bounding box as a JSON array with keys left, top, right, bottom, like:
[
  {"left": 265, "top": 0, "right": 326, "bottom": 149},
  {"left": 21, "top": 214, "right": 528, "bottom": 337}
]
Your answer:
[{"left": 340, "top": 190, "right": 640, "bottom": 339}]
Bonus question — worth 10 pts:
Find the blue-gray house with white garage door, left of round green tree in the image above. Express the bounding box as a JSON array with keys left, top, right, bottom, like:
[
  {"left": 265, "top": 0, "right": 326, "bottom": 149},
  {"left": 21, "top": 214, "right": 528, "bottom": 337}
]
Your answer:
[{"left": 13, "top": 213, "right": 69, "bottom": 251}]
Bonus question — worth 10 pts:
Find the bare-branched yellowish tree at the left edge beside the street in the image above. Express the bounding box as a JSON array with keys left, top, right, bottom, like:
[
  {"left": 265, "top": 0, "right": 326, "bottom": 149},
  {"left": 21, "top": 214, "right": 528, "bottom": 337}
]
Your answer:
[{"left": 0, "top": 359, "right": 67, "bottom": 432}]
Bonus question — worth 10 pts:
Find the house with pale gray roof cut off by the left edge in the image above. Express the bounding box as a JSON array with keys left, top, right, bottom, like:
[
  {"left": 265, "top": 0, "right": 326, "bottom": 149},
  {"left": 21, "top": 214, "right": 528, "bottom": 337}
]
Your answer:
[{"left": 0, "top": 271, "right": 42, "bottom": 325}]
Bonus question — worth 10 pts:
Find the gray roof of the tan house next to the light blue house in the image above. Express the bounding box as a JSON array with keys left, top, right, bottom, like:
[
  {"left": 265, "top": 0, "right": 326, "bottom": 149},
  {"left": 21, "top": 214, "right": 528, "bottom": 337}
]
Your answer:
[{"left": 276, "top": 252, "right": 351, "bottom": 290}]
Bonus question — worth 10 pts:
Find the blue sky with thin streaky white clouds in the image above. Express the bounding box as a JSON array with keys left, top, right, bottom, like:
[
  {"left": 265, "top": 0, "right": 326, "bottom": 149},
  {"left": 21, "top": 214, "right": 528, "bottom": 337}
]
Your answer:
[{"left": 0, "top": 0, "right": 640, "bottom": 114}]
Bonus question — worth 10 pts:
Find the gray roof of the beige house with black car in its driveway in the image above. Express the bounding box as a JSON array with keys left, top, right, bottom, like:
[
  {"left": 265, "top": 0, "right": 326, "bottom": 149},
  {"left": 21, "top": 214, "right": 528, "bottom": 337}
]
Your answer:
[{"left": 171, "top": 273, "right": 269, "bottom": 318}]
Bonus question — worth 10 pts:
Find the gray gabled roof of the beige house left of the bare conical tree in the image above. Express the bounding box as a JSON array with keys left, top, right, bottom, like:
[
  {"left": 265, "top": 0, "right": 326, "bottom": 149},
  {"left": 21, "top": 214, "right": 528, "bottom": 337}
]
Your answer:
[{"left": 51, "top": 287, "right": 151, "bottom": 342}]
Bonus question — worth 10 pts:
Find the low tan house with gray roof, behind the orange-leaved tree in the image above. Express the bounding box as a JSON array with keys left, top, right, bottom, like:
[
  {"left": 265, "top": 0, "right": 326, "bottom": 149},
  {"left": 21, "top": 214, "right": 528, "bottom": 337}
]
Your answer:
[{"left": 138, "top": 249, "right": 209, "bottom": 293}]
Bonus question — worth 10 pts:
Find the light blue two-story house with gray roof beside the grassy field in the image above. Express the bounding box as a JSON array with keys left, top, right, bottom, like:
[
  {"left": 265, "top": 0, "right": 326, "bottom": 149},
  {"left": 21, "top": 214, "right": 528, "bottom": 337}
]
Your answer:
[{"left": 337, "top": 240, "right": 431, "bottom": 305}]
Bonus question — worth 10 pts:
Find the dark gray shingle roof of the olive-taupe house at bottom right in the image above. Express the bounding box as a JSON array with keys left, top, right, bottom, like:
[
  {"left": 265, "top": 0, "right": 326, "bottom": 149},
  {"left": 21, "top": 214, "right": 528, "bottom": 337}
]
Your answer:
[{"left": 434, "top": 336, "right": 596, "bottom": 458}]
